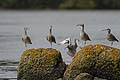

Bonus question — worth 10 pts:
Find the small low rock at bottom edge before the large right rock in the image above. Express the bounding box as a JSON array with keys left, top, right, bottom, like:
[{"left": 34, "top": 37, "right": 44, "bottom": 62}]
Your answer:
[{"left": 74, "top": 73, "right": 94, "bottom": 80}]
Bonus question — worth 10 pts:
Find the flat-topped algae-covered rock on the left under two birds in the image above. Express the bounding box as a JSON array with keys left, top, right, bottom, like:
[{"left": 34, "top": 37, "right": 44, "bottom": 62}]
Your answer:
[{"left": 17, "top": 48, "right": 66, "bottom": 80}]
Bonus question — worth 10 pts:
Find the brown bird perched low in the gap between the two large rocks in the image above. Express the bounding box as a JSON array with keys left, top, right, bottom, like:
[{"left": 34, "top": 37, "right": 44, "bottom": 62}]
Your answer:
[{"left": 65, "top": 39, "right": 79, "bottom": 57}]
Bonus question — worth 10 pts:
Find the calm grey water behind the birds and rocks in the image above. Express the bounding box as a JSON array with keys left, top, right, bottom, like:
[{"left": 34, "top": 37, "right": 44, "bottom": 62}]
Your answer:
[{"left": 0, "top": 11, "right": 120, "bottom": 80}]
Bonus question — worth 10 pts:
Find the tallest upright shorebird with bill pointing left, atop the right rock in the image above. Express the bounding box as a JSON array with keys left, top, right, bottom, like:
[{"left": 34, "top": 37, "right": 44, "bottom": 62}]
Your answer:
[{"left": 76, "top": 24, "right": 91, "bottom": 46}]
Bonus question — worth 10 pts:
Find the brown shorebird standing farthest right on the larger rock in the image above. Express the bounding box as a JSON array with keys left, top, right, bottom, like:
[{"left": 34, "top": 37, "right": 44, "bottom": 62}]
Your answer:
[{"left": 102, "top": 28, "right": 119, "bottom": 46}]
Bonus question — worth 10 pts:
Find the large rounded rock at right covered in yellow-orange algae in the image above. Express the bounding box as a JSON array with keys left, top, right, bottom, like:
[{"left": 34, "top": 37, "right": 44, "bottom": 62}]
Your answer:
[{"left": 64, "top": 44, "right": 120, "bottom": 80}]
